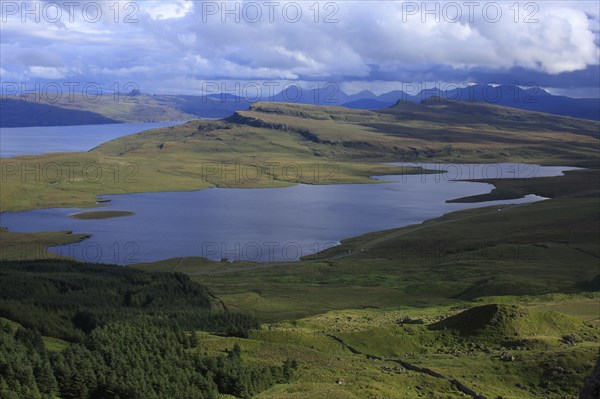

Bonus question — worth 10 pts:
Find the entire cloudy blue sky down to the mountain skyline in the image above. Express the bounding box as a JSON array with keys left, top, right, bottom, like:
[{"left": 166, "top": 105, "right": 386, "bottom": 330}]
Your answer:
[{"left": 0, "top": 0, "right": 600, "bottom": 97}]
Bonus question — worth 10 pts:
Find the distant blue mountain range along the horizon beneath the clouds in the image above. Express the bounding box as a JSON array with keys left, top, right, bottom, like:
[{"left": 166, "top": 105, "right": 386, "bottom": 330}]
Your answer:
[{"left": 0, "top": 85, "right": 600, "bottom": 127}]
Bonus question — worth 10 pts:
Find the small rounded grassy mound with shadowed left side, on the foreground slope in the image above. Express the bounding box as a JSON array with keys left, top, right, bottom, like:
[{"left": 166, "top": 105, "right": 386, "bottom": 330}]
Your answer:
[{"left": 429, "top": 304, "right": 594, "bottom": 342}]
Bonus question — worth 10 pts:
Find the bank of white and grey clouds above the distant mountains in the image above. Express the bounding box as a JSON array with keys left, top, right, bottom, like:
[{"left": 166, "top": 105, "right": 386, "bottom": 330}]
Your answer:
[{"left": 0, "top": 0, "right": 600, "bottom": 90}]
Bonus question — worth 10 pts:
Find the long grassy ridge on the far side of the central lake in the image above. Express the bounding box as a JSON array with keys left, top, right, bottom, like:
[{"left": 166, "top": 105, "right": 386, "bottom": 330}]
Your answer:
[{"left": 0, "top": 100, "right": 600, "bottom": 211}]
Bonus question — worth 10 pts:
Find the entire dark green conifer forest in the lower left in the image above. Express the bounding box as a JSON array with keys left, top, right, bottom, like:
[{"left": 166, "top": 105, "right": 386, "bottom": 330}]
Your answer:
[{"left": 0, "top": 261, "right": 297, "bottom": 399}]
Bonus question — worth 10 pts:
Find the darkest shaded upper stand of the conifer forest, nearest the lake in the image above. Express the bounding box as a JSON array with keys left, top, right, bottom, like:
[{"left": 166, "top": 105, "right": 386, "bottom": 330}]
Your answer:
[{"left": 0, "top": 260, "right": 259, "bottom": 342}]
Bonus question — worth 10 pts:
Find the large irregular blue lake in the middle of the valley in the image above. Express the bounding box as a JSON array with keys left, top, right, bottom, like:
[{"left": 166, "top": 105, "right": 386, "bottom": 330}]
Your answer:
[{"left": 0, "top": 164, "right": 574, "bottom": 264}]
